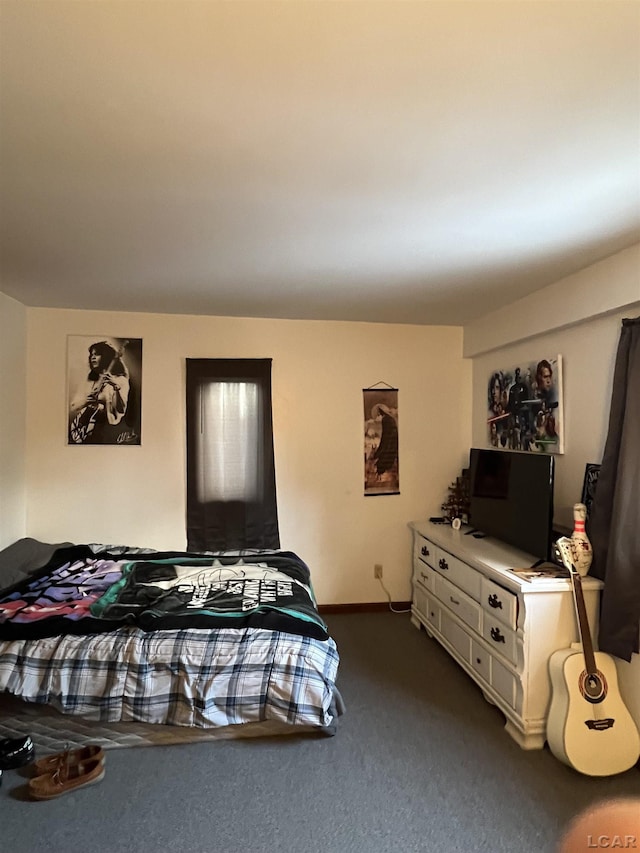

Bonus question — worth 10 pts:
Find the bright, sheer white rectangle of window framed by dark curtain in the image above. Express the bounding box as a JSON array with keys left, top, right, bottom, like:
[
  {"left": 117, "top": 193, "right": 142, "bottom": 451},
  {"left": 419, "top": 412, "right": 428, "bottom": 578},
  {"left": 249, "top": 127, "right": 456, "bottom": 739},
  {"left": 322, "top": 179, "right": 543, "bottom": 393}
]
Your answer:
[{"left": 196, "top": 381, "right": 262, "bottom": 502}]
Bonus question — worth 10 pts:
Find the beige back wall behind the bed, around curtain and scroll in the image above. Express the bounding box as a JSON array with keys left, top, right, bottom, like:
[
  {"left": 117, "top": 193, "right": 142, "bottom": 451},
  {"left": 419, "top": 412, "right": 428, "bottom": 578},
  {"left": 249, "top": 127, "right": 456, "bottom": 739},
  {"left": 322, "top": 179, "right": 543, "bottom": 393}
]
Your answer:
[{"left": 27, "top": 309, "right": 471, "bottom": 604}]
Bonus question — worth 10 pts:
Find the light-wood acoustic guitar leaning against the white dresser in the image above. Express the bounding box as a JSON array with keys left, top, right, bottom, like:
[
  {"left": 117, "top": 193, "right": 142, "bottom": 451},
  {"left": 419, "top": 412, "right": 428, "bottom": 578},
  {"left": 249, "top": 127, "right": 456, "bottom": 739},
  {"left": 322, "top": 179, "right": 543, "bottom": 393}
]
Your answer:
[{"left": 547, "top": 537, "right": 640, "bottom": 776}]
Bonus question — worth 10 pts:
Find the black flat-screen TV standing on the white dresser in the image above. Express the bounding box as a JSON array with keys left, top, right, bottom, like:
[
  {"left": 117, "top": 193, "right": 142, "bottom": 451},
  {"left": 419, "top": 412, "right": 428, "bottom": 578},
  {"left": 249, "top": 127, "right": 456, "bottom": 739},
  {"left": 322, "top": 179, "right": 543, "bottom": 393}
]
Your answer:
[{"left": 469, "top": 447, "right": 554, "bottom": 560}]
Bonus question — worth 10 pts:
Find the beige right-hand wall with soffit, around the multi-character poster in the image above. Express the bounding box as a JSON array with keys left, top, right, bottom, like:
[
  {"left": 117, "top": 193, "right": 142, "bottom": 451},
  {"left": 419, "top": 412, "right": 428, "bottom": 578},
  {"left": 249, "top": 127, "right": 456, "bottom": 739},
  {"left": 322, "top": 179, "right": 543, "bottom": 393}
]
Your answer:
[{"left": 464, "top": 246, "right": 640, "bottom": 727}]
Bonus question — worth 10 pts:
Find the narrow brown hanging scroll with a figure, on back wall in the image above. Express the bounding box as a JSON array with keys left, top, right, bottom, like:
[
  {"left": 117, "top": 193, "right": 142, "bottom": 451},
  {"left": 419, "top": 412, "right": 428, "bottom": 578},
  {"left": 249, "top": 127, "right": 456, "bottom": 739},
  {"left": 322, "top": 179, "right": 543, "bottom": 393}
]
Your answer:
[{"left": 362, "top": 388, "right": 400, "bottom": 496}]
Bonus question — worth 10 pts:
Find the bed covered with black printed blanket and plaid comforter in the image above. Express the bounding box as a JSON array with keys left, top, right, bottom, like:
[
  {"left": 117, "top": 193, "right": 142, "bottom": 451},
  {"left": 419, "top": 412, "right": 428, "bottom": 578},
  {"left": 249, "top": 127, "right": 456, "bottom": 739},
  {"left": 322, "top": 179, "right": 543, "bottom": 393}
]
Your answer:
[{"left": 0, "top": 539, "right": 344, "bottom": 736}]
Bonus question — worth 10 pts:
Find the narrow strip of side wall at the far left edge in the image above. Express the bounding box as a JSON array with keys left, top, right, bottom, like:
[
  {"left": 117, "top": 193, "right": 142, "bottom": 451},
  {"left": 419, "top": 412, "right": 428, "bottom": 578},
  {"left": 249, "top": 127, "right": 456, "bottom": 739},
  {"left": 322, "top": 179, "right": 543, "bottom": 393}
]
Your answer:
[{"left": 0, "top": 293, "right": 27, "bottom": 548}]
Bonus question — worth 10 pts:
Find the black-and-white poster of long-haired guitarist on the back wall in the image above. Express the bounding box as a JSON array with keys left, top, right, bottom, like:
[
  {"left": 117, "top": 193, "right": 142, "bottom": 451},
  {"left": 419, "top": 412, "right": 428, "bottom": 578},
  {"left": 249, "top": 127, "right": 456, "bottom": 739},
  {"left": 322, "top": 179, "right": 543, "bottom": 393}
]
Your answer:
[{"left": 67, "top": 335, "right": 142, "bottom": 444}]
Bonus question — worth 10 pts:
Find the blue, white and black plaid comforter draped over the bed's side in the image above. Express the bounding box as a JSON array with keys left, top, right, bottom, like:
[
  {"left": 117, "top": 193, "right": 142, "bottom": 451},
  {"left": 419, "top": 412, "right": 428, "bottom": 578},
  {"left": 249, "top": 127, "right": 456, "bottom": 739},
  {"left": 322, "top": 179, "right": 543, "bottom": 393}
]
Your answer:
[{"left": 0, "top": 627, "right": 338, "bottom": 728}]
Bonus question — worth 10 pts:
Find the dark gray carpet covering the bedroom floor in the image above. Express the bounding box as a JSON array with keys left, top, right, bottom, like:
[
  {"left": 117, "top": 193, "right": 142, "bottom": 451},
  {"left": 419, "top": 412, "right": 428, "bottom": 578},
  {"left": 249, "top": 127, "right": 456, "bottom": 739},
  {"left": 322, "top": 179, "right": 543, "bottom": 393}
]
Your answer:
[{"left": 0, "top": 613, "right": 640, "bottom": 853}]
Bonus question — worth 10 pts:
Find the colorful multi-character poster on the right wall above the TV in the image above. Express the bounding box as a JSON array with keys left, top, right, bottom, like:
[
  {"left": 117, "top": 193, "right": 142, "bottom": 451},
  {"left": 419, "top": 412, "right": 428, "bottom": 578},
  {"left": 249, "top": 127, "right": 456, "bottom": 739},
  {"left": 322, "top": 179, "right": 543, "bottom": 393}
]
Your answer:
[{"left": 487, "top": 355, "right": 564, "bottom": 453}]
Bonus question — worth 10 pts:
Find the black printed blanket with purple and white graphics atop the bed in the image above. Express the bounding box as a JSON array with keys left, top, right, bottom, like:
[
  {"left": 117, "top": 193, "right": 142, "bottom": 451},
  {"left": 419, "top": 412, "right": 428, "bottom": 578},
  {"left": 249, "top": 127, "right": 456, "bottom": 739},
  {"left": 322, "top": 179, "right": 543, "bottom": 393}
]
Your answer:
[{"left": 0, "top": 545, "right": 328, "bottom": 640}]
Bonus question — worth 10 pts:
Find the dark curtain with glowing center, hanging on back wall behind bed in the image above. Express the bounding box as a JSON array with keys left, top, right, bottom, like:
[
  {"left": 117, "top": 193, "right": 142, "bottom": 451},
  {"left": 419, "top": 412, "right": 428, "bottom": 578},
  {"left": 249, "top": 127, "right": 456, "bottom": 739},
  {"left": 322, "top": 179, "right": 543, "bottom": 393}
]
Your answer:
[{"left": 182, "top": 359, "right": 280, "bottom": 551}]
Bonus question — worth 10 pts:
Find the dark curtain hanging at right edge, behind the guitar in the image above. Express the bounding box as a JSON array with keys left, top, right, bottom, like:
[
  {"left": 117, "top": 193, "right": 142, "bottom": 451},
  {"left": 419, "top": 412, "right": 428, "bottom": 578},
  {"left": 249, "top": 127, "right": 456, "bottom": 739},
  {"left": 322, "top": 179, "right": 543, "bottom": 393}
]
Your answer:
[{"left": 589, "top": 317, "right": 640, "bottom": 661}]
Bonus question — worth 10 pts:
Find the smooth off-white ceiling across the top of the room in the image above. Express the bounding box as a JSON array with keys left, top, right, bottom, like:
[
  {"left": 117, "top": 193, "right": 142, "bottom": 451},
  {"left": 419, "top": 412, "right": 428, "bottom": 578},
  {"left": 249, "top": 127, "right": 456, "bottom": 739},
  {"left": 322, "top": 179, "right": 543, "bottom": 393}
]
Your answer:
[{"left": 0, "top": 0, "right": 640, "bottom": 325}]
